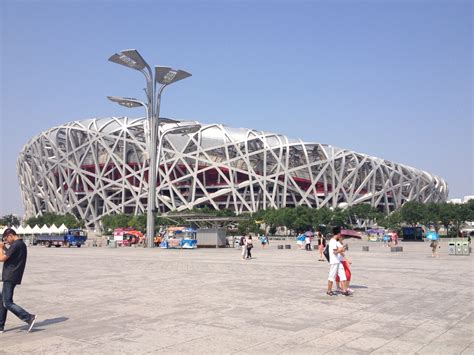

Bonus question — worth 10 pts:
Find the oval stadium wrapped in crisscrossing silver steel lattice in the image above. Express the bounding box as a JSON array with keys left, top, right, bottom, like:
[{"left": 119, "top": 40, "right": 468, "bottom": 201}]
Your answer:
[{"left": 17, "top": 117, "right": 448, "bottom": 227}]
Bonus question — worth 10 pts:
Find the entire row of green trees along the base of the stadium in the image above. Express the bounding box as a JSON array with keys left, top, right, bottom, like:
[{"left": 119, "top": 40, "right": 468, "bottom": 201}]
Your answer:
[{"left": 0, "top": 200, "right": 474, "bottom": 235}]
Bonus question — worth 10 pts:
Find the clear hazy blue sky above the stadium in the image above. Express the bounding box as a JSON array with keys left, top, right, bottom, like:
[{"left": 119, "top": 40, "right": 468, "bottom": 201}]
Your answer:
[{"left": 0, "top": 0, "right": 474, "bottom": 215}]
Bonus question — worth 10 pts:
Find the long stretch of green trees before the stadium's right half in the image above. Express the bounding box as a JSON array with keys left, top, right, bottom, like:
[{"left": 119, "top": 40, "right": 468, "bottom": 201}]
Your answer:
[{"left": 239, "top": 200, "right": 474, "bottom": 235}]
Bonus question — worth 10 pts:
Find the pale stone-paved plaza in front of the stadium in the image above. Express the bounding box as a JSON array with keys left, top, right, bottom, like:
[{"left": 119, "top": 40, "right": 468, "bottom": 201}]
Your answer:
[{"left": 0, "top": 240, "right": 474, "bottom": 354}]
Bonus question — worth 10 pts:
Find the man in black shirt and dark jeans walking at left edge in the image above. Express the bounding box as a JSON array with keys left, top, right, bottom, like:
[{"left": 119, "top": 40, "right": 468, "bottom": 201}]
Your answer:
[{"left": 0, "top": 228, "right": 36, "bottom": 333}]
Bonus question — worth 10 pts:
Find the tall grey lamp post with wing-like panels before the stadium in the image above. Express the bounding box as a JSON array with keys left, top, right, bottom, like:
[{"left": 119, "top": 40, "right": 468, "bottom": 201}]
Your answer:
[{"left": 109, "top": 49, "right": 191, "bottom": 248}]
